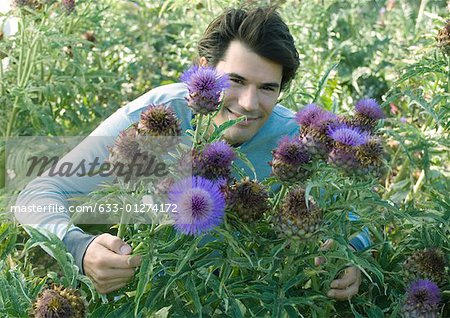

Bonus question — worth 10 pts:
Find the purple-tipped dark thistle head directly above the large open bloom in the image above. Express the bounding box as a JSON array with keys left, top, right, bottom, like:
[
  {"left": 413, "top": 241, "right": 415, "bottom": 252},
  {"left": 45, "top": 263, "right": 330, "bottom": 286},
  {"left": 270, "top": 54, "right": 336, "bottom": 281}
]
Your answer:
[{"left": 192, "top": 141, "right": 236, "bottom": 180}]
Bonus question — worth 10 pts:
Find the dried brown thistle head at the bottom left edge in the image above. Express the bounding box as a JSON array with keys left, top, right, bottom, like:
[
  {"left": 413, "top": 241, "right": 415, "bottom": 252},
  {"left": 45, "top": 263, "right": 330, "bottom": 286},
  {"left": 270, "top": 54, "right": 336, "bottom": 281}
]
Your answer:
[{"left": 33, "top": 286, "right": 86, "bottom": 318}]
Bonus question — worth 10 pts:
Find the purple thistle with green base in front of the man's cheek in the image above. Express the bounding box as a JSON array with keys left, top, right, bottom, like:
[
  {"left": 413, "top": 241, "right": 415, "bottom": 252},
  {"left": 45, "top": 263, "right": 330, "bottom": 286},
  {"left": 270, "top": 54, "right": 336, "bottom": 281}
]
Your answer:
[{"left": 180, "top": 65, "right": 230, "bottom": 114}]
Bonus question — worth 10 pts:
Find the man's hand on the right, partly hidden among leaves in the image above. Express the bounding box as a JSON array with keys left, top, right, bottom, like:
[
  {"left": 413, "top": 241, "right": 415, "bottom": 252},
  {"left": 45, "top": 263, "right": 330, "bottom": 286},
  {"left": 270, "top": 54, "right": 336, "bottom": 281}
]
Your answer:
[{"left": 314, "top": 240, "right": 361, "bottom": 300}]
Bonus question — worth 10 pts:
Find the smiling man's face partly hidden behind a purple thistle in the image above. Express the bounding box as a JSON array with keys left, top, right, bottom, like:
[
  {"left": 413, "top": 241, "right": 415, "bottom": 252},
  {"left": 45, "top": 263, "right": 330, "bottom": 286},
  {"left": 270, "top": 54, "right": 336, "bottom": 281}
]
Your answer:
[{"left": 207, "top": 41, "right": 282, "bottom": 145}]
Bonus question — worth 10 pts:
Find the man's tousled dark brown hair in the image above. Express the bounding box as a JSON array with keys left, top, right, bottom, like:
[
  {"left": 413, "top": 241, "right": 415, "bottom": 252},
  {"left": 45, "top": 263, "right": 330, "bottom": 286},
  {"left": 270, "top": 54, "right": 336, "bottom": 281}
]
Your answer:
[{"left": 198, "top": 6, "right": 299, "bottom": 89}]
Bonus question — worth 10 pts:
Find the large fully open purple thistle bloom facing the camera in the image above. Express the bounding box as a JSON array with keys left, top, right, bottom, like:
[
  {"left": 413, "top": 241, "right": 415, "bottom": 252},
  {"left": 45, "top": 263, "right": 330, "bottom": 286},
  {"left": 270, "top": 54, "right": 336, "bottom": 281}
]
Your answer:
[{"left": 169, "top": 177, "right": 225, "bottom": 235}]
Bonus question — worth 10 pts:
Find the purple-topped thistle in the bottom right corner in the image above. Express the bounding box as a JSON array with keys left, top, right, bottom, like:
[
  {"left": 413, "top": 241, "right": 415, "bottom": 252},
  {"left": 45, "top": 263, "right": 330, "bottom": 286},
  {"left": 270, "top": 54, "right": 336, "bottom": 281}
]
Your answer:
[{"left": 406, "top": 279, "right": 441, "bottom": 307}]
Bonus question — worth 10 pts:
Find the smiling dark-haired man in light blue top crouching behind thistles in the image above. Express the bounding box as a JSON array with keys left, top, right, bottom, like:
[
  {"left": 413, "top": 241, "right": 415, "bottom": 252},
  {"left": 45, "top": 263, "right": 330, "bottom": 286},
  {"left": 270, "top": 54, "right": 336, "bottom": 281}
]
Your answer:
[{"left": 19, "top": 8, "right": 370, "bottom": 299}]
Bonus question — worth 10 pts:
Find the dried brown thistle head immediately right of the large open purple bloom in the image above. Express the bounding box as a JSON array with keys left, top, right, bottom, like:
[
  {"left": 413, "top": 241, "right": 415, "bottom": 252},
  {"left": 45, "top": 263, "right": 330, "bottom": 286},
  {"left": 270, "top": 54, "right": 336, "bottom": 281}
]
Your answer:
[{"left": 225, "top": 177, "right": 270, "bottom": 222}]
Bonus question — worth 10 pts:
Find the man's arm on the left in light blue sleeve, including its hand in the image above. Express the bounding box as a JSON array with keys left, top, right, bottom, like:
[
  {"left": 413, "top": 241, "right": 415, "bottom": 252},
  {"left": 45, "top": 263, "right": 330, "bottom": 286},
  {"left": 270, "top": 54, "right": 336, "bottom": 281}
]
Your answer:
[{"left": 15, "top": 105, "right": 140, "bottom": 293}]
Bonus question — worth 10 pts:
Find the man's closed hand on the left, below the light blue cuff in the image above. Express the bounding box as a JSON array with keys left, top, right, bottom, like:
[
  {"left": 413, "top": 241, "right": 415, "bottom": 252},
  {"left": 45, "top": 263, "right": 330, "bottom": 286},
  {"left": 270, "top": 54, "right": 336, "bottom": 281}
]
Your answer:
[{"left": 83, "top": 233, "right": 141, "bottom": 294}]
